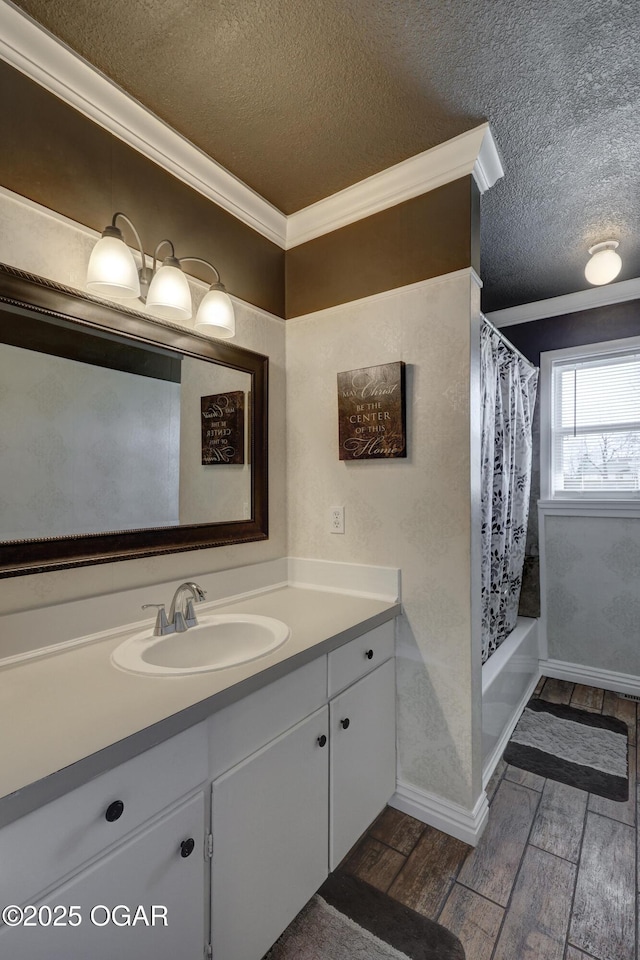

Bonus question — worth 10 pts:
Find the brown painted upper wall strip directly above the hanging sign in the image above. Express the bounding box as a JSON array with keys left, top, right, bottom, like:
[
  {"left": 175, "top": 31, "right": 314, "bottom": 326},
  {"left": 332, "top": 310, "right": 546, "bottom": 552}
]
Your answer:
[{"left": 286, "top": 176, "right": 480, "bottom": 318}]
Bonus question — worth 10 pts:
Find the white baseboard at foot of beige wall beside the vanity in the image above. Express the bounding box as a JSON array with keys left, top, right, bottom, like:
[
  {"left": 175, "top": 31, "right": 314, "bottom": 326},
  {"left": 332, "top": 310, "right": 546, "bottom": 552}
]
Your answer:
[{"left": 389, "top": 781, "right": 489, "bottom": 847}]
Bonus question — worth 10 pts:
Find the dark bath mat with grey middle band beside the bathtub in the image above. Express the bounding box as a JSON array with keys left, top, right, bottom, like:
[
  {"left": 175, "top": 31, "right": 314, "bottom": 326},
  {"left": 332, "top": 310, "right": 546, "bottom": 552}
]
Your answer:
[{"left": 504, "top": 700, "right": 629, "bottom": 802}]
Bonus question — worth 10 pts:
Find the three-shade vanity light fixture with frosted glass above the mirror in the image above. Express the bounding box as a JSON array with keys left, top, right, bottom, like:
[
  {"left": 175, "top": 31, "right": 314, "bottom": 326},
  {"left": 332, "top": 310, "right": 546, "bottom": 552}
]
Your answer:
[{"left": 87, "top": 211, "right": 236, "bottom": 339}]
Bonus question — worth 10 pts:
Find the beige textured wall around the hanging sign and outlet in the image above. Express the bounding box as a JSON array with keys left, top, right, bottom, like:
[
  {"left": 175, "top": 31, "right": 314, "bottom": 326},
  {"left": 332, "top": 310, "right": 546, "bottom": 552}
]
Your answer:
[{"left": 287, "top": 270, "right": 481, "bottom": 809}]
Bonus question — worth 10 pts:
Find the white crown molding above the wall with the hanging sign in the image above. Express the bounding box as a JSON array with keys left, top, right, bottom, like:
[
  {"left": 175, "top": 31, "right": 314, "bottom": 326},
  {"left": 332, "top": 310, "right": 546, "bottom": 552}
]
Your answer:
[{"left": 286, "top": 123, "right": 504, "bottom": 249}]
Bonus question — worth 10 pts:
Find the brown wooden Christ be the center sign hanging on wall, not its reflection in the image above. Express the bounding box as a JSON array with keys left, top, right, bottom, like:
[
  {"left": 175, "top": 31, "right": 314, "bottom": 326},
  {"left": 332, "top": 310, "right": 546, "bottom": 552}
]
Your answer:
[{"left": 338, "top": 360, "right": 407, "bottom": 460}]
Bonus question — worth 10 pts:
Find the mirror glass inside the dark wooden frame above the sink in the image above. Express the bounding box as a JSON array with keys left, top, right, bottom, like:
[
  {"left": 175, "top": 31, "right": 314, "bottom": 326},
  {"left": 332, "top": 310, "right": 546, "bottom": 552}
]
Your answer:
[{"left": 0, "top": 316, "right": 251, "bottom": 540}]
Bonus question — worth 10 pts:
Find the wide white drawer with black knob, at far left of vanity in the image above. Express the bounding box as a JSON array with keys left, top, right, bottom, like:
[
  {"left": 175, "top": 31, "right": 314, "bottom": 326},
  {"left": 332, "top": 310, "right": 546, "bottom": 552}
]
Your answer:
[{"left": 0, "top": 721, "right": 208, "bottom": 904}]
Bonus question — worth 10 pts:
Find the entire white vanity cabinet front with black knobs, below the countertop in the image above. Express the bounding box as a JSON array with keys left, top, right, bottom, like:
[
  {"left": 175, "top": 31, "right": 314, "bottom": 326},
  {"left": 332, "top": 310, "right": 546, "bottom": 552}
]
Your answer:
[{"left": 0, "top": 621, "right": 396, "bottom": 960}]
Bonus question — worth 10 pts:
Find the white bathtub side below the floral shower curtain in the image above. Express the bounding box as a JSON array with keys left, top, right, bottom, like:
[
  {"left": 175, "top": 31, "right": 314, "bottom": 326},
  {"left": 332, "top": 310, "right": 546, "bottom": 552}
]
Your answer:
[{"left": 482, "top": 617, "right": 540, "bottom": 786}]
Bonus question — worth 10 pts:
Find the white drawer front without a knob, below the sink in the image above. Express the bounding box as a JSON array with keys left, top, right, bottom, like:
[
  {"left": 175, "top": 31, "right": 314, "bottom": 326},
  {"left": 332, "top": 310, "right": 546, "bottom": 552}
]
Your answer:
[{"left": 209, "top": 656, "right": 327, "bottom": 780}]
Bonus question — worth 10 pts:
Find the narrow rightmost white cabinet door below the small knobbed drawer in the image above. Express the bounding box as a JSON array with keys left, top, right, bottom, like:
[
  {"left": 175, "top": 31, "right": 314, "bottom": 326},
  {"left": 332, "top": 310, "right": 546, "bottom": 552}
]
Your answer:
[{"left": 329, "top": 660, "right": 396, "bottom": 870}]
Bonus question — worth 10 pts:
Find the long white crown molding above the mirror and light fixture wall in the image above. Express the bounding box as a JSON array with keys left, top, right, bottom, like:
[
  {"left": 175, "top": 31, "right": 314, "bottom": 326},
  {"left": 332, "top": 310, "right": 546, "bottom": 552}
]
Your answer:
[{"left": 0, "top": 2, "right": 287, "bottom": 247}]
